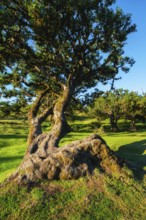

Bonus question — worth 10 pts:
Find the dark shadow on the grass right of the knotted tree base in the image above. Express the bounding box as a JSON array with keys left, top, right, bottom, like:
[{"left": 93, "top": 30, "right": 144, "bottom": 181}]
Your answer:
[{"left": 116, "top": 140, "right": 146, "bottom": 180}]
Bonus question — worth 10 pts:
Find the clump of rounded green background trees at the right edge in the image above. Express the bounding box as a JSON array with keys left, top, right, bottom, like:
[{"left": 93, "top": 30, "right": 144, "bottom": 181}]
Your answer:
[{"left": 88, "top": 89, "right": 146, "bottom": 131}]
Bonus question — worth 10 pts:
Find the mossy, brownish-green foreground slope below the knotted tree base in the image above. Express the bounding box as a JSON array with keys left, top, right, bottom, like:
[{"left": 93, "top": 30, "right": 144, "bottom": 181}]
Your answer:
[{"left": 0, "top": 171, "right": 146, "bottom": 220}]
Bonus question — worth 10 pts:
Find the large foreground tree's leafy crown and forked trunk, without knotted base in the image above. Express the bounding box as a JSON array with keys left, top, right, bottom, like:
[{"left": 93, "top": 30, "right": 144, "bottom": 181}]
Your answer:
[{"left": 0, "top": 0, "right": 135, "bottom": 182}]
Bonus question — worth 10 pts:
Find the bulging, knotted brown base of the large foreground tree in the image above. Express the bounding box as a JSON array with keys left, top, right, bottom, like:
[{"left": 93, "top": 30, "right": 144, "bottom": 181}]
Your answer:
[{"left": 8, "top": 135, "right": 123, "bottom": 183}]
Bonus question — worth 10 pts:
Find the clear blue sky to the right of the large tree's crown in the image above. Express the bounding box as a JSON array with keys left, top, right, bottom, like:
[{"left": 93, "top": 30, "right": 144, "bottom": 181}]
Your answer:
[{"left": 100, "top": 0, "right": 146, "bottom": 93}]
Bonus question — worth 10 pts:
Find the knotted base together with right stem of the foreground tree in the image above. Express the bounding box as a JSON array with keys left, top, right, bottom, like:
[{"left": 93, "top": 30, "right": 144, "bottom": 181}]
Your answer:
[{"left": 6, "top": 86, "right": 125, "bottom": 183}]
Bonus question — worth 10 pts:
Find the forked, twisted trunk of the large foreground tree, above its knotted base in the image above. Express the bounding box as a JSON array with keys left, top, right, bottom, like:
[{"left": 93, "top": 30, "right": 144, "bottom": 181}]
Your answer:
[{"left": 13, "top": 86, "right": 71, "bottom": 179}]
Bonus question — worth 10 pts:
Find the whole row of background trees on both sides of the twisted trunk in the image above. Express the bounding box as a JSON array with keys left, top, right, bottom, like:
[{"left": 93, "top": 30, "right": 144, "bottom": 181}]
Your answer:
[{"left": 0, "top": 89, "right": 146, "bottom": 131}]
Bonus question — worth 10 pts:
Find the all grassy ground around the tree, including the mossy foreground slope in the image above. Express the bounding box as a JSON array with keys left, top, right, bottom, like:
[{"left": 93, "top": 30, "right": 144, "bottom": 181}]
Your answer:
[{"left": 0, "top": 116, "right": 146, "bottom": 220}]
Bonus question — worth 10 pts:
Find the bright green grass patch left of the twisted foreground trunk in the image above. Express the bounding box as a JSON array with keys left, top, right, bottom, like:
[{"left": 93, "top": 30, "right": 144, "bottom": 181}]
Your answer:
[{"left": 0, "top": 121, "right": 28, "bottom": 182}]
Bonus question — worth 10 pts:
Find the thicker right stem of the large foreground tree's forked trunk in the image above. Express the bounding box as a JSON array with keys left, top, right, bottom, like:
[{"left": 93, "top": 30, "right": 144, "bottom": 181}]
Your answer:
[{"left": 27, "top": 86, "right": 71, "bottom": 158}]
